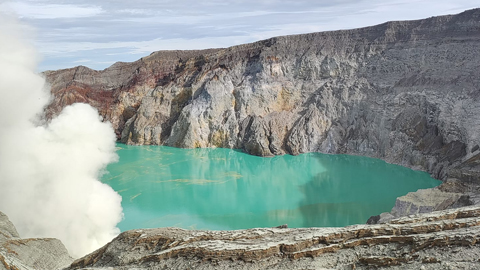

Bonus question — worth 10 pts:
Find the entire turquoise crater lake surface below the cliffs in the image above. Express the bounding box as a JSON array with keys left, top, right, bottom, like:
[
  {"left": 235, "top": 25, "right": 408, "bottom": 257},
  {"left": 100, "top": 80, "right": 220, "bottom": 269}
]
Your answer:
[{"left": 102, "top": 144, "right": 440, "bottom": 231}]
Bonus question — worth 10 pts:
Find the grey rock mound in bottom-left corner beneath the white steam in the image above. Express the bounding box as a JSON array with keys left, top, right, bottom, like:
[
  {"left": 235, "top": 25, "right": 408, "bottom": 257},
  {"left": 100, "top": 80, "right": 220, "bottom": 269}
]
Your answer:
[{"left": 0, "top": 212, "right": 73, "bottom": 270}]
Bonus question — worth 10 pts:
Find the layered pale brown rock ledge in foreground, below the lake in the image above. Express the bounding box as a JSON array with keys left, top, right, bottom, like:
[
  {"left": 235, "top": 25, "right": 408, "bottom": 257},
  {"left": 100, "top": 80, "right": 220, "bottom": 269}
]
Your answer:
[{"left": 68, "top": 206, "right": 480, "bottom": 269}]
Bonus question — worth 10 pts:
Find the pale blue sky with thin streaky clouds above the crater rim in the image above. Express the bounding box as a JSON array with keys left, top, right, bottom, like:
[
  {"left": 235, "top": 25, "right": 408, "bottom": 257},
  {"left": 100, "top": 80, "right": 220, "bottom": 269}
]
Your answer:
[{"left": 0, "top": 0, "right": 480, "bottom": 71}]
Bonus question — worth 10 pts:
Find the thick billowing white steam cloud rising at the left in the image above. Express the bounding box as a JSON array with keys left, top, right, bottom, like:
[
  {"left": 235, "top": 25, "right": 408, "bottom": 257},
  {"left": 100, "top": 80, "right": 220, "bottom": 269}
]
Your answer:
[{"left": 0, "top": 13, "right": 122, "bottom": 257}]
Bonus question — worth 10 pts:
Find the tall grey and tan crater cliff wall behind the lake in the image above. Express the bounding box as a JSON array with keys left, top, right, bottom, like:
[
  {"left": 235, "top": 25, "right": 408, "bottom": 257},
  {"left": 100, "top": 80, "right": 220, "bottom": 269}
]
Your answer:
[{"left": 45, "top": 9, "right": 480, "bottom": 184}]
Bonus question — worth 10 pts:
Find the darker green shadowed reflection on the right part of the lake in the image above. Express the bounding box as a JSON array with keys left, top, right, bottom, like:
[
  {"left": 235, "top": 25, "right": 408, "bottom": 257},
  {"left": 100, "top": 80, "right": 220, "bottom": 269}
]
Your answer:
[{"left": 299, "top": 153, "right": 440, "bottom": 227}]
